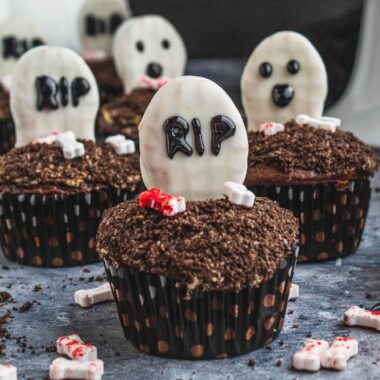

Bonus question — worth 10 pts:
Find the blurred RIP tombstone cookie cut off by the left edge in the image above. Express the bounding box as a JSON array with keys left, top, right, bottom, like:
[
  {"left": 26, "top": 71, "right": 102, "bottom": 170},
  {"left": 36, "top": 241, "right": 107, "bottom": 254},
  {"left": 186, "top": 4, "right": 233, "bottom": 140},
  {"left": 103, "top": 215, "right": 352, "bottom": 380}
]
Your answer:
[{"left": 0, "top": 18, "right": 46, "bottom": 78}]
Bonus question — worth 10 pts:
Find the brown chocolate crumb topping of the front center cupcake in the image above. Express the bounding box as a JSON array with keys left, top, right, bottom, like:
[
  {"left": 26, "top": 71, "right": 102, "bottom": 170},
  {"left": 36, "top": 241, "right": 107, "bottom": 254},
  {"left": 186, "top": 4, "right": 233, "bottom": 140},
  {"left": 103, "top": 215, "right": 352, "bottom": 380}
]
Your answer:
[{"left": 96, "top": 198, "right": 298, "bottom": 291}]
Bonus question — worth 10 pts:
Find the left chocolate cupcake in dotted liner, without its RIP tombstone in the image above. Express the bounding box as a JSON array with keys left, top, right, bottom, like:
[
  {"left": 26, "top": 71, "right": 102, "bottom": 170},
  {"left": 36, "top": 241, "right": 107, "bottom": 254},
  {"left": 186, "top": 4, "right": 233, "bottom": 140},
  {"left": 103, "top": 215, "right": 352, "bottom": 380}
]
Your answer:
[{"left": 0, "top": 138, "right": 141, "bottom": 267}]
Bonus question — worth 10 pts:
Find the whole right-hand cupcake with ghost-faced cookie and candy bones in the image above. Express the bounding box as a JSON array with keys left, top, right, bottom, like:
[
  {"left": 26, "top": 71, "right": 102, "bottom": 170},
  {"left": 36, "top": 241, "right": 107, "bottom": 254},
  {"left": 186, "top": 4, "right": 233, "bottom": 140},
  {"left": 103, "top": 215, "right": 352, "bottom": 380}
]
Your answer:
[{"left": 241, "top": 32, "right": 377, "bottom": 261}]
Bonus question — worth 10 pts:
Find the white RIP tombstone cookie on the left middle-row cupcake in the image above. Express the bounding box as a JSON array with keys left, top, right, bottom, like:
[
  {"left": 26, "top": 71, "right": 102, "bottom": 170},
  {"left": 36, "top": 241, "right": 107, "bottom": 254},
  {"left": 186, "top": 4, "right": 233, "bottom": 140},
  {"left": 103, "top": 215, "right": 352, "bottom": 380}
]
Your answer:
[{"left": 10, "top": 46, "right": 99, "bottom": 146}]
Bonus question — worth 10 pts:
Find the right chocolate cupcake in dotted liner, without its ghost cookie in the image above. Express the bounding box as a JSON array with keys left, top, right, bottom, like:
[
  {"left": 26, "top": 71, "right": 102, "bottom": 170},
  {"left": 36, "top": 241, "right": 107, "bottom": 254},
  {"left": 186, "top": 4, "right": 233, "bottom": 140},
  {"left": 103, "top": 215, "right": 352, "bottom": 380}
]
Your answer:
[{"left": 245, "top": 117, "right": 378, "bottom": 261}]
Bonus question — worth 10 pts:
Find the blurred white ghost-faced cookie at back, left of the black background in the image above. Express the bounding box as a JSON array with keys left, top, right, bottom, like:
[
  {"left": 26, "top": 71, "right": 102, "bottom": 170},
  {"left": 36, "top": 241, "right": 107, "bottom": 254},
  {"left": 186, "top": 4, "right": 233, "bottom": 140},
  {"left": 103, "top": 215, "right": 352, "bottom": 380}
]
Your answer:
[{"left": 113, "top": 15, "right": 187, "bottom": 93}]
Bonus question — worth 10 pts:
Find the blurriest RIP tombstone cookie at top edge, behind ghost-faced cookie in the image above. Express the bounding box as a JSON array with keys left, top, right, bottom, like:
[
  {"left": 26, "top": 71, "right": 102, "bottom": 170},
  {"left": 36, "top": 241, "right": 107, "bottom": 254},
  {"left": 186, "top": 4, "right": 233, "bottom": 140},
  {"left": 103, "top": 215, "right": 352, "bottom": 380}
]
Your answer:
[{"left": 78, "top": 0, "right": 132, "bottom": 58}]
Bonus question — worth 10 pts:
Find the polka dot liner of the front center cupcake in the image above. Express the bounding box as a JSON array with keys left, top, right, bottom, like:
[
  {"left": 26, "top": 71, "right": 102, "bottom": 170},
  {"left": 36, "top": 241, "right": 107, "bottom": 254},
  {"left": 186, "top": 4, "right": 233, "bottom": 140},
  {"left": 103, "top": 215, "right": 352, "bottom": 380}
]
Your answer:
[{"left": 105, "top": 248, "right": 298, "bottom": 359}]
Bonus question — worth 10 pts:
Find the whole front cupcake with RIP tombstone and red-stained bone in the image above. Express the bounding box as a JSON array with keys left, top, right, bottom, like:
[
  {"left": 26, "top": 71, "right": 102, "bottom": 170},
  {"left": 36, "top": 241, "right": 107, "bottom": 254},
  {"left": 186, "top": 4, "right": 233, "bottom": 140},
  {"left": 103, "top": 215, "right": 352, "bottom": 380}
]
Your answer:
[{"left": 97, "top": 77, "right": 298, "bottom": 359}]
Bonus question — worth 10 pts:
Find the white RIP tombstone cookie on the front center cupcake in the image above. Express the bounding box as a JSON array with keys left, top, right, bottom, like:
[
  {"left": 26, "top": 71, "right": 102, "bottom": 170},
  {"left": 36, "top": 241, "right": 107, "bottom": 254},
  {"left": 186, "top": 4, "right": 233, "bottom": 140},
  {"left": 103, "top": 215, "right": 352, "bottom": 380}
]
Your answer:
[{"left": 139, "top": 76, "right": 248, "bottom": 200}]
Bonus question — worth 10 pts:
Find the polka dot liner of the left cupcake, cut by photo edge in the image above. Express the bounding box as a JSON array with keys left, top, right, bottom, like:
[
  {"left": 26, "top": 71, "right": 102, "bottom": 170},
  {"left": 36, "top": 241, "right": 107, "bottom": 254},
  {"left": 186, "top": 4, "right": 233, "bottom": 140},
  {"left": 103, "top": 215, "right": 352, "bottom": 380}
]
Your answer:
[{"left": 0, "top": 189, "right": 137, "bottom": 267}]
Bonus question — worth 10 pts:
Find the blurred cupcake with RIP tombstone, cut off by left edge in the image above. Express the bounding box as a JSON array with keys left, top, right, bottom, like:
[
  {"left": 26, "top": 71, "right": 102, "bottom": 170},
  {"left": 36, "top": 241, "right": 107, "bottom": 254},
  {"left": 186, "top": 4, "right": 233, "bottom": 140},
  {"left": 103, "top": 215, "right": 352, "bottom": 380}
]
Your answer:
[{"left": 0, "top": 18, "right": 45, "bottom": 154}]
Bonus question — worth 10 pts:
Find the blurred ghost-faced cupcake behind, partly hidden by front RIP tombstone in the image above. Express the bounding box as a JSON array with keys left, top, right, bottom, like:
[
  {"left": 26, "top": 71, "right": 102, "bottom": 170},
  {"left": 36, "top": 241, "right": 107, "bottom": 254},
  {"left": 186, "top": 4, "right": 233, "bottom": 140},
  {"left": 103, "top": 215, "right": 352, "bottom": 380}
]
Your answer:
[{"left": 97, "top": 15, "right": 187, "bottom": 150}]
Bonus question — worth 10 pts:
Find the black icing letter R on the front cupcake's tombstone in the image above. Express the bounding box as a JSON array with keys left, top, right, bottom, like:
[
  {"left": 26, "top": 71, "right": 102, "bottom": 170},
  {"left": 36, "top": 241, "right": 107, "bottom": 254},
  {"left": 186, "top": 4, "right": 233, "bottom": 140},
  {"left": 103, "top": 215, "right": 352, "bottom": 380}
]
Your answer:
[{"left": 163, "top": 116, "right": 193, "bottom": 159}]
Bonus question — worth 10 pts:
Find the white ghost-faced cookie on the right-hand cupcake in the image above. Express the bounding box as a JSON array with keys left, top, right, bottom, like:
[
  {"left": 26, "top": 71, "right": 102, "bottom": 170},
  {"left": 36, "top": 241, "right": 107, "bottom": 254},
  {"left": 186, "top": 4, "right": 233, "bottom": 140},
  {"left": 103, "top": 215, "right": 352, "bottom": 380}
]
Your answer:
[{"left": 241, "top": 32, "right": 327, "bottom": 131}]
